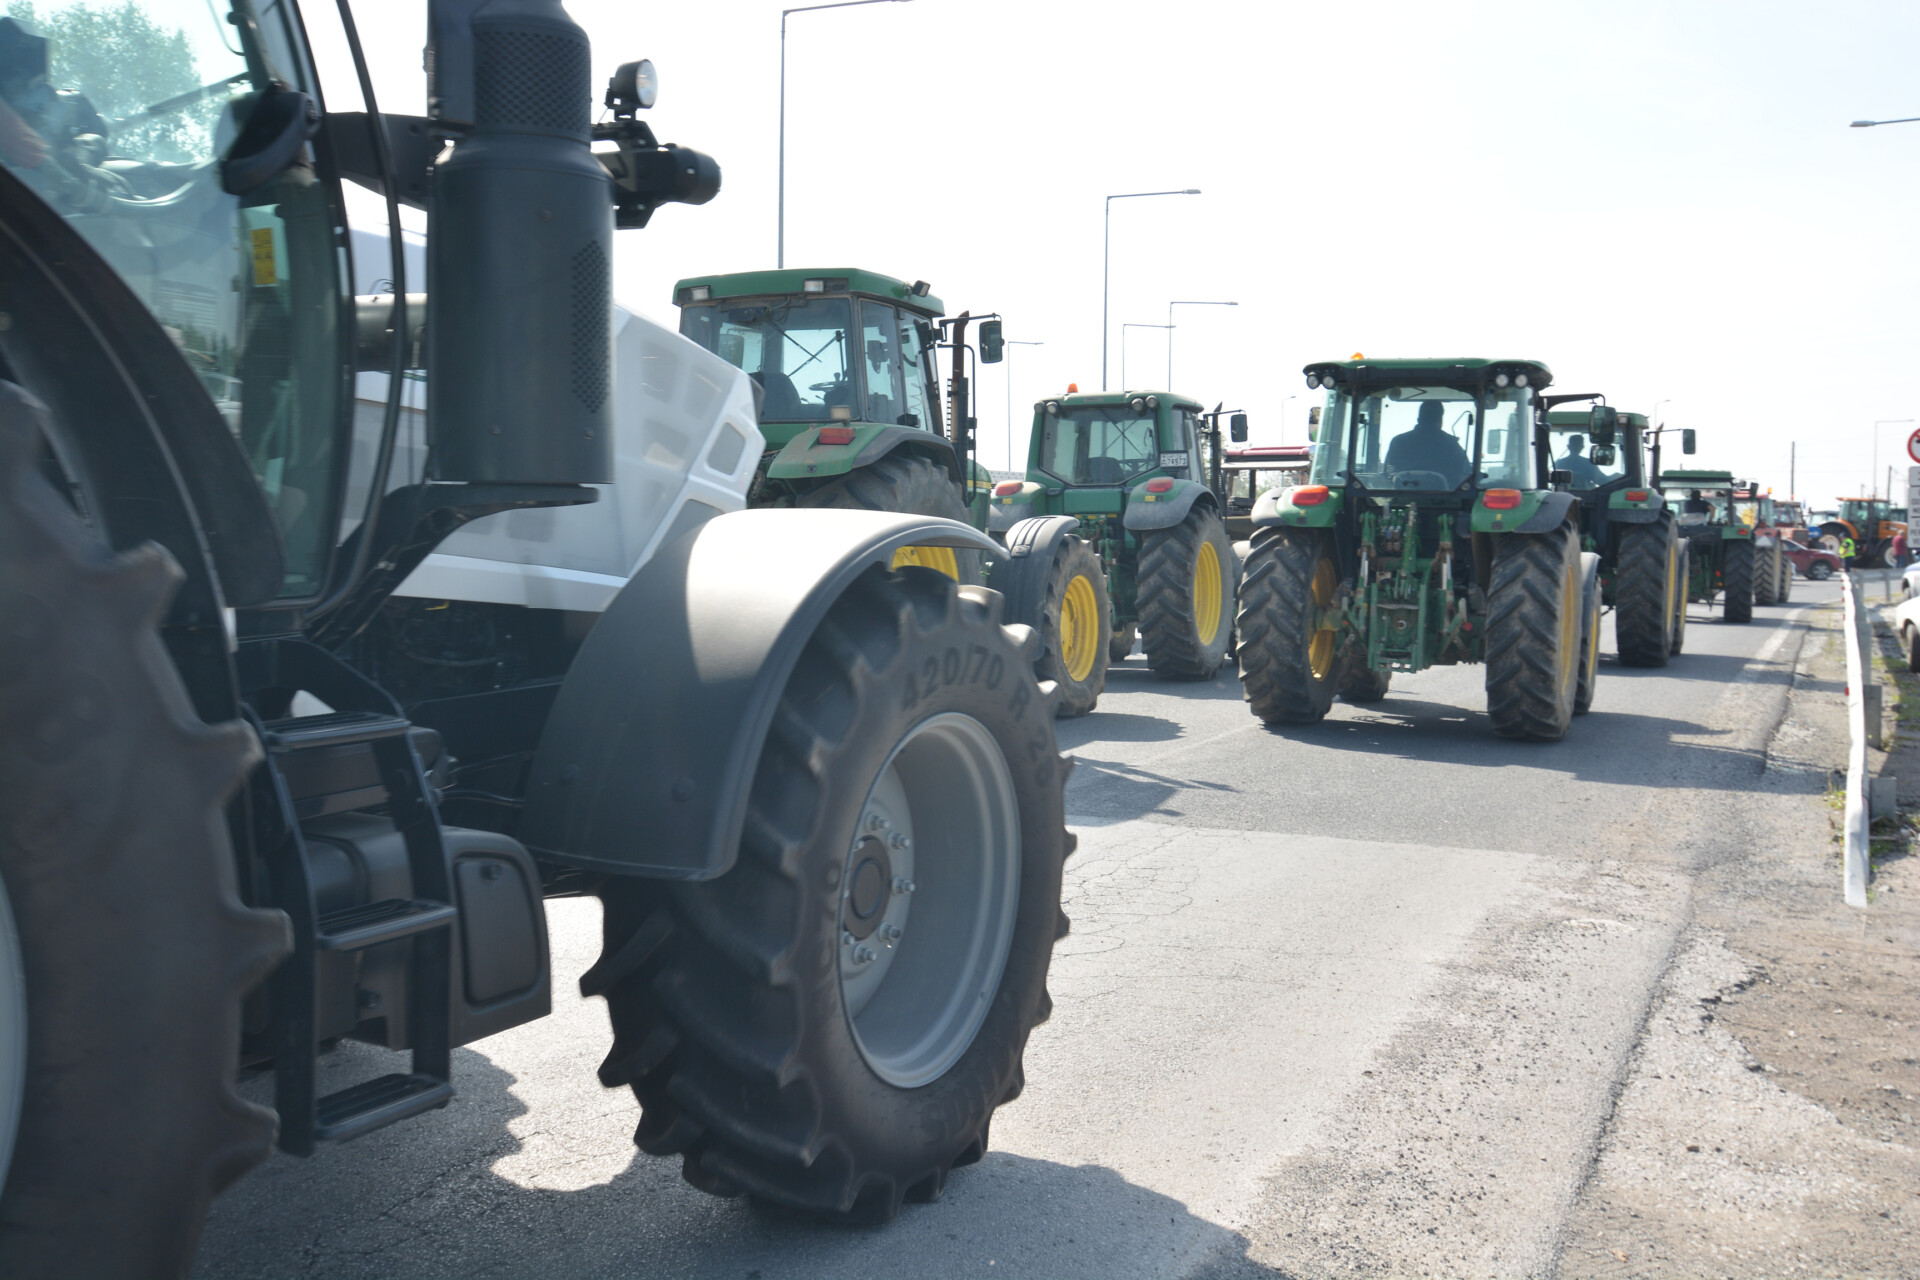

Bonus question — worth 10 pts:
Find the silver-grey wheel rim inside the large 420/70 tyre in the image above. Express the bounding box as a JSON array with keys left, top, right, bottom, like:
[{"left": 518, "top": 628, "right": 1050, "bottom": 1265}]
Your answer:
[{"left": 839, "top": 712, "right": 1020, "bottom": 1088}]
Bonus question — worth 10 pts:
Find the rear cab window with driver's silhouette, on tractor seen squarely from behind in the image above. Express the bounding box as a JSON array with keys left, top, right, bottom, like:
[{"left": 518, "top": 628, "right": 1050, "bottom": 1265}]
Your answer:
[{"left": 1313, "top": 386, "right": 1532, "bottom": 493}]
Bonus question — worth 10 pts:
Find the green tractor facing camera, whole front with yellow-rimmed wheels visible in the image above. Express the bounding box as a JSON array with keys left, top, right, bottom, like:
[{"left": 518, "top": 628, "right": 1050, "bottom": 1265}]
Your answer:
[{"left": 987, "top": 390, "right": 1246, "bottom": 716}]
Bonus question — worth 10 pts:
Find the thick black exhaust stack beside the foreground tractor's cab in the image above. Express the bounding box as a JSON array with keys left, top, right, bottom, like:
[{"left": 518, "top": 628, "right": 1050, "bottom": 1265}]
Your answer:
[{"left": 426, "top": 0, "right": 614, "bottom": 484}]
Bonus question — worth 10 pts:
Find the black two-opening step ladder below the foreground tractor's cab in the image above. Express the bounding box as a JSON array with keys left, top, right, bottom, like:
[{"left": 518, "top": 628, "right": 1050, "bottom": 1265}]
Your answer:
[{"left": 257, "top": 645, "right": 459, "bottom": 1155}]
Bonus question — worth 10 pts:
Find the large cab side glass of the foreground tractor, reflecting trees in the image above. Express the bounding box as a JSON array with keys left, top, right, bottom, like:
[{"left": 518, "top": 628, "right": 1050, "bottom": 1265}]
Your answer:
[{"left": 0, "top": 0, "right": 349, "bottom": 597}]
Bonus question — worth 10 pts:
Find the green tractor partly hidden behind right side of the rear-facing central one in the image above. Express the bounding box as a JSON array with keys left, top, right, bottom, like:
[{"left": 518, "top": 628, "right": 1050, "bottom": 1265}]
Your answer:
[{"left": 1540, "top": 402, "right": 1693, "bottom": 666}]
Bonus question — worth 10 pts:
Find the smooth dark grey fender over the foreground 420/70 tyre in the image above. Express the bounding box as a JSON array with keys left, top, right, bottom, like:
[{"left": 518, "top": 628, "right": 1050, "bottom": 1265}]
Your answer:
[{"left": 518, "top": 509, "right": 1004, "bottom": 881}]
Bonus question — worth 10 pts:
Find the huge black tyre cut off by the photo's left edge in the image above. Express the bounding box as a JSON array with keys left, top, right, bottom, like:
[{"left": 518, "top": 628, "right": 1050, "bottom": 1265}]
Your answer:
[{"left": 0, "top": 384, "right": 290, "bottom": 1276}]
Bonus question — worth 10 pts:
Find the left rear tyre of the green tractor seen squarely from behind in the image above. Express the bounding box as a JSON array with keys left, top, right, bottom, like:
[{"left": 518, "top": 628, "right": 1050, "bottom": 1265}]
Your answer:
[{"left": 1238, "top": 528, "right": 1342, "bottom": 723}]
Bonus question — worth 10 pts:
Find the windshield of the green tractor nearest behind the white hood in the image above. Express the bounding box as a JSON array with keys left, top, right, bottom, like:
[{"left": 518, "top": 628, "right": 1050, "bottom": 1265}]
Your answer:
[{"left": 680, "top": 297, "right": 852, "bottom": 422}]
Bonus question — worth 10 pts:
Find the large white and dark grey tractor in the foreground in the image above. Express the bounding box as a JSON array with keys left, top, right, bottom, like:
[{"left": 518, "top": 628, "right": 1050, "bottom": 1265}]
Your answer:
[{"left": 0, "top": 0, "right": 1071, "bottom": 1276}]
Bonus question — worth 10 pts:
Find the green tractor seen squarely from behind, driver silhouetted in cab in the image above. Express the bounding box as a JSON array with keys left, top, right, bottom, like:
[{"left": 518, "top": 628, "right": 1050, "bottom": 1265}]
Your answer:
[{"left": 1238, "top": 359, "right": 1601, "bottom": 741}]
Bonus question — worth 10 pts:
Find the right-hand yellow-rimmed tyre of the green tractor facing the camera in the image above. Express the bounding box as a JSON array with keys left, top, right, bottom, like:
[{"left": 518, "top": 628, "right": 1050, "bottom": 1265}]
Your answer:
[{"left": 1135, "top": 503, "right": 1238, "bottom": 679}]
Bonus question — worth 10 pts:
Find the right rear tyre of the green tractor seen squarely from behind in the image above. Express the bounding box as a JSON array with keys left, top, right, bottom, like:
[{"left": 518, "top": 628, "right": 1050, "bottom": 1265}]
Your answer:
[{"left": 1486, "top": 526, "right": 1582, "bottom": 743}]
